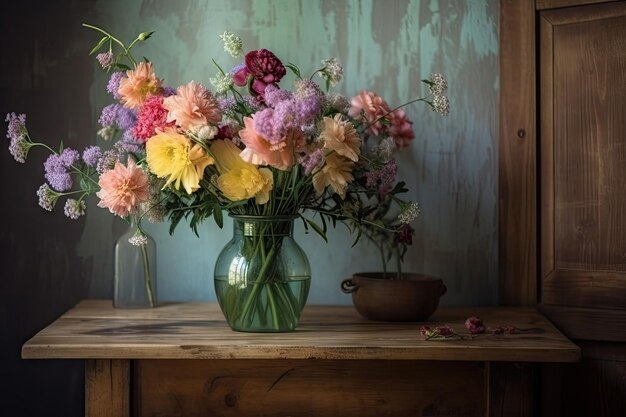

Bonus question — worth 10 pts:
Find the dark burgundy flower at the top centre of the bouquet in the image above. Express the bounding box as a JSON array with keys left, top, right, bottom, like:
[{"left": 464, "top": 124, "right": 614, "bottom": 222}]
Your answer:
[{"left": 233, "top": 49, "right": 287, "bottom": 96}]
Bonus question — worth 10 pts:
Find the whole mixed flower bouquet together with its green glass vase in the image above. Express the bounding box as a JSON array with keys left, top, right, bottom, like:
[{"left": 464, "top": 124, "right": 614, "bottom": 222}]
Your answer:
[{"left": 7, "top": 25, "right": 448, "bottom": 331}]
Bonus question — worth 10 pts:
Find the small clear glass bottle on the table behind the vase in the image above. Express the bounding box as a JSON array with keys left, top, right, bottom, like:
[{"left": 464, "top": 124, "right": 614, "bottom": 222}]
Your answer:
[{"left": 113, "top": 218, "right": 157, "bottom": 308}]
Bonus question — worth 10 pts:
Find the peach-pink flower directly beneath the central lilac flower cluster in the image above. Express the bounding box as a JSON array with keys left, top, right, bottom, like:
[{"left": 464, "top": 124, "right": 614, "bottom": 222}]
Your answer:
[{"left": 239, "top": 117, "right": 304, "bottom": 170}]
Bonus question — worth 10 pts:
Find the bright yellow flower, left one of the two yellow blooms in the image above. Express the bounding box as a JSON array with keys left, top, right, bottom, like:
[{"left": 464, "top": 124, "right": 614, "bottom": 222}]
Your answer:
[{"left": 146, "top": 129, "right": 214, "bottom": 194}]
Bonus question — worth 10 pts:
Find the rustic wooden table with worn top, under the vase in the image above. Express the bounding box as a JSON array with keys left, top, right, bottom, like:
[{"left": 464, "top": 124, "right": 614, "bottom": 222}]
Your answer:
[{"left": 22, "top": 300, "right": 580, "bottom": 417}]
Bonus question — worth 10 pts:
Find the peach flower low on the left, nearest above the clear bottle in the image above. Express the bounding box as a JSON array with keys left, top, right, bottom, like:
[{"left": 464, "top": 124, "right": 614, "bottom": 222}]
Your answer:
[{"left": 96, "top": 157, "right": 150, "bottom": 217}]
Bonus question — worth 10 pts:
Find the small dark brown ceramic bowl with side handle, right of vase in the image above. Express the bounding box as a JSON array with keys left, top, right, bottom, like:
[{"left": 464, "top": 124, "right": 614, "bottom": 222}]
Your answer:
[{"left": 341, "top": 272, "right": 447, "bottom": 321}]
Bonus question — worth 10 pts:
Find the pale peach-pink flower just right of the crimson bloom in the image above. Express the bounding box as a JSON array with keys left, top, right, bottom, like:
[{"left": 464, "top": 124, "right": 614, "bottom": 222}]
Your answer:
[{"left": 163, "top": 81, "right": 222, "bottom": 130}]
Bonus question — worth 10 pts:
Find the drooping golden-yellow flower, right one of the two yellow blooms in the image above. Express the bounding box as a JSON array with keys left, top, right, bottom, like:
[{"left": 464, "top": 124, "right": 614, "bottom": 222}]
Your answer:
[{"left": 211, "top": 140, "right": 274, "bottom": 204}]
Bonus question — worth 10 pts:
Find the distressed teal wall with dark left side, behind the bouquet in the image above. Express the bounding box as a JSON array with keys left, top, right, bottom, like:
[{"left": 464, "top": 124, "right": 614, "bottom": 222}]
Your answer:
[{"left": 0, "top": 0, "right": 498, "bottom": 416}]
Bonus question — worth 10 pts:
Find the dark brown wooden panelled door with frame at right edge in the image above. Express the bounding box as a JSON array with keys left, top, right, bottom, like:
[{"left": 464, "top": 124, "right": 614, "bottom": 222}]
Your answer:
[{"left": 500, "top": 0, "right": 626, "bottom": 417}]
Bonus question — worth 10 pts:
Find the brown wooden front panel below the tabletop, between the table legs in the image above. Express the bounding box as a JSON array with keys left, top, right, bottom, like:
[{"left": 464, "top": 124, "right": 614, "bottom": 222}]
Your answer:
[{"left": 135, "top": 360, "right": 486, "bottom": 417}]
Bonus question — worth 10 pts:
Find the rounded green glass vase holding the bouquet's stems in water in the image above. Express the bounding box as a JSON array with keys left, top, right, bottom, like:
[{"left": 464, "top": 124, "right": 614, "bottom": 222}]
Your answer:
[{"left": 214, "top": 215, "right": 311, "bottom": 332}]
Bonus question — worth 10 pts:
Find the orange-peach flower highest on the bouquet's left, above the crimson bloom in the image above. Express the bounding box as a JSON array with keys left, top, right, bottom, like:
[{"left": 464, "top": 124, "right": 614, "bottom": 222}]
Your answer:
[{"left": 117, "top": 62, "right": 161, "bottom": 109}]
